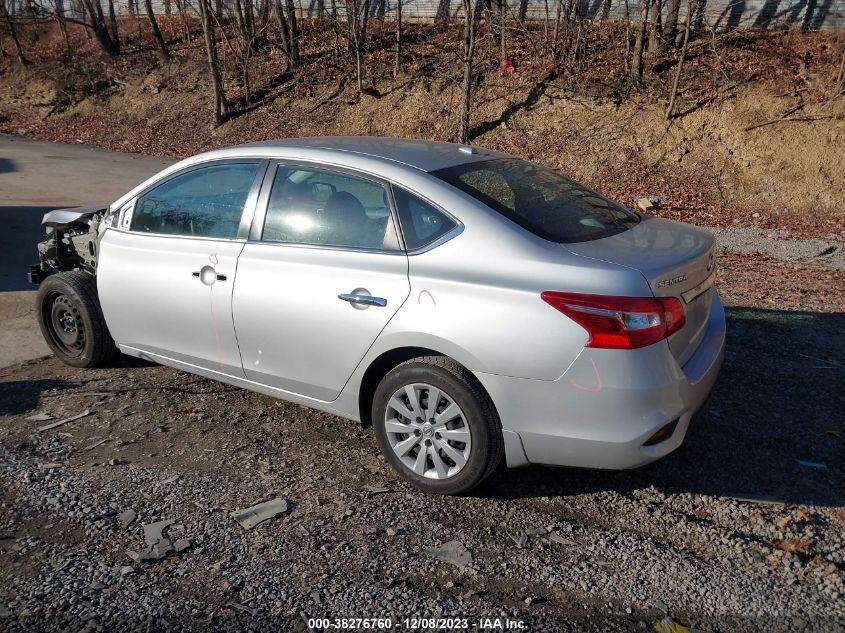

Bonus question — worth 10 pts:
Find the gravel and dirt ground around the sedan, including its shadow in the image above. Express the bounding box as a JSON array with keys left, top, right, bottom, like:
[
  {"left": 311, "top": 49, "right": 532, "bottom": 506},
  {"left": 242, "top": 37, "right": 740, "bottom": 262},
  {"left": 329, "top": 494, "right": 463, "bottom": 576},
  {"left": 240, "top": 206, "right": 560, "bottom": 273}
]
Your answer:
[{"left": 0, "top": 256, "right": 845, "bottom": 632}]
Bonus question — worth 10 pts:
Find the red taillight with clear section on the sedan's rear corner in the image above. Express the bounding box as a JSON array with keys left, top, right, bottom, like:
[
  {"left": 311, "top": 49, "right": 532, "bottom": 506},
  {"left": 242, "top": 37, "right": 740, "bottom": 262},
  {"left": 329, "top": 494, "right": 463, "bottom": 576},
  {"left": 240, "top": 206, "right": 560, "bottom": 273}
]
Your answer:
[{"left": 540, "top": 290, "right": 684, "bottom": 349}]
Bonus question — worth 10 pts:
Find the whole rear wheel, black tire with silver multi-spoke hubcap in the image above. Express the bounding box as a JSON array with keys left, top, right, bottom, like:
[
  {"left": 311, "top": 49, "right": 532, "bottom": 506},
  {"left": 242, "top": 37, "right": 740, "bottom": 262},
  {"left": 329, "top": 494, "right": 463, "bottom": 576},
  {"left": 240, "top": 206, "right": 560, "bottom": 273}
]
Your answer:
[{"left": 372, "top": 356, "right": 504, "bottom": 495}]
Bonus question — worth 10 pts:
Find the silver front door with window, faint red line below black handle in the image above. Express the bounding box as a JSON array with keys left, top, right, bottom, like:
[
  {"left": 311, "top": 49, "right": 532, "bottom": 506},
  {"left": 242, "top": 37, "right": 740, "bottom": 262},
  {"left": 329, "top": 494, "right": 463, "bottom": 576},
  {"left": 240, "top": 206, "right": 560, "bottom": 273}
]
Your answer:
[{"left": 97, "top": 160, "right": 267, "bottom": 377}]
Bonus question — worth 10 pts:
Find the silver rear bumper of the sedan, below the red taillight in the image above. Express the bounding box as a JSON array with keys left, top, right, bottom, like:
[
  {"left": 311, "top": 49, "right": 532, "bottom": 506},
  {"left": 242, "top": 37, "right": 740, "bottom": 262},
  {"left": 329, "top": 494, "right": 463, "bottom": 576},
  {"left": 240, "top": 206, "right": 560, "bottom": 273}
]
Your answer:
[{"left": 476, "top": 289, "right": 725, "bottom": 469}]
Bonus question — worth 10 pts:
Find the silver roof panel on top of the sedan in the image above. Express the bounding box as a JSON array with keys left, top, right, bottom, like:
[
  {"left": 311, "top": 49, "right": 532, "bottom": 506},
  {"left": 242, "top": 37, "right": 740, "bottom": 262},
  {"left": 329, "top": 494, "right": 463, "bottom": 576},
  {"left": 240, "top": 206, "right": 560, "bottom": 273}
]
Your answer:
[{"left": 205, "top": 136, "right": 511, "bottom": 172}]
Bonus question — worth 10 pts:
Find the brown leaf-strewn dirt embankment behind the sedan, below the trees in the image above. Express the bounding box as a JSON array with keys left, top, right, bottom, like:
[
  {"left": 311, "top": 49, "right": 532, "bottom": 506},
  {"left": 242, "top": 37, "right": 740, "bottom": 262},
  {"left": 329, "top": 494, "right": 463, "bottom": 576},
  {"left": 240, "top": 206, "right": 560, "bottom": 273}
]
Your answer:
[{"left": 0, "top": 24, "right": 845, "bottom": 239}]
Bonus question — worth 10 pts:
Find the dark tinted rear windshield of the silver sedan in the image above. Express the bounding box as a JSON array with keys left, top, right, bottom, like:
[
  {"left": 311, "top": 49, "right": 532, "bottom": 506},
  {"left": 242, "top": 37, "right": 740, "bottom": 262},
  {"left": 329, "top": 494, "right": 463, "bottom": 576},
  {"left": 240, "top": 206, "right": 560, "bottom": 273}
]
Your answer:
[{"left": 432, "top": 158, "right": 640, "bottom": 244}]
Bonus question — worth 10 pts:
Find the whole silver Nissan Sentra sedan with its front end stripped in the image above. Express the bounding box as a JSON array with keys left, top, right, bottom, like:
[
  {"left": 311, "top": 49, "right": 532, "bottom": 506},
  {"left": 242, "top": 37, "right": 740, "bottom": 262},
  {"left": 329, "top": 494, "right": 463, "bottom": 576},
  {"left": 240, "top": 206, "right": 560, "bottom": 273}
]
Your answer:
[{"left": 30, "top": 137, "right": 725, "bottom": 494}]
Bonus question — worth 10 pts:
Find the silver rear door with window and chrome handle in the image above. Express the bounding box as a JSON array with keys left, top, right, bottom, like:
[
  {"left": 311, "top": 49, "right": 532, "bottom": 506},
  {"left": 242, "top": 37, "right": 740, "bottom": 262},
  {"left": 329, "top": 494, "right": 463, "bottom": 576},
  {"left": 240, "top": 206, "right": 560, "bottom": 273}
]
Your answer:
[{"left": 233, "top": 163, "right": 410, "bottom": 401}]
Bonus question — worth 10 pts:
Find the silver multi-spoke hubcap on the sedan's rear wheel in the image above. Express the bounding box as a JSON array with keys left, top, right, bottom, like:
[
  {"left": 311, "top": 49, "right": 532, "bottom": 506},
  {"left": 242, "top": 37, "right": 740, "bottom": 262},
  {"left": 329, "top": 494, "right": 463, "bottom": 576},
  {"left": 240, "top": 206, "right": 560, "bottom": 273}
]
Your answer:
[{"left": 384, "top": 383, "right": 472, "bottom": 479}]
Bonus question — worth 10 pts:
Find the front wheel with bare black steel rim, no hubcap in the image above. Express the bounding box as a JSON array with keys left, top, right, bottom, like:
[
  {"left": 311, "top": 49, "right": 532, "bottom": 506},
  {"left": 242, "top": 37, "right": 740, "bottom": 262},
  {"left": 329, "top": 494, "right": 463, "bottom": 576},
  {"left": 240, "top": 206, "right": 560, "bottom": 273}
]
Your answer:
[{"left": 36, "top": 270, "right": 118, "bottom": 367}]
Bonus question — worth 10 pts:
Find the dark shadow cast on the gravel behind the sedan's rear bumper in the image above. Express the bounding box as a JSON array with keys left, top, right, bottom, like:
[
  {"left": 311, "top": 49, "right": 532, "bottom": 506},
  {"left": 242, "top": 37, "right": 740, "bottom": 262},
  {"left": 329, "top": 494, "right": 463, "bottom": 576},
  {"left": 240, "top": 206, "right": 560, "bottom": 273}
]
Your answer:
[{"left": 477, "top": 308, "right": 845, "bottom": 505}]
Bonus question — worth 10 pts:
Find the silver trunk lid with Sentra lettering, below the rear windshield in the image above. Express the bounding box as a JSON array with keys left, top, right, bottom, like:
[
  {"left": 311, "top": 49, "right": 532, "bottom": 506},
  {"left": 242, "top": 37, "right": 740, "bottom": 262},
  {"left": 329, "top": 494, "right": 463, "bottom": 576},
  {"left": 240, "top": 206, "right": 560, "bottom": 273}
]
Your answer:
[{"left": 565, "top": 217, "right": 716, "bottom": 366}]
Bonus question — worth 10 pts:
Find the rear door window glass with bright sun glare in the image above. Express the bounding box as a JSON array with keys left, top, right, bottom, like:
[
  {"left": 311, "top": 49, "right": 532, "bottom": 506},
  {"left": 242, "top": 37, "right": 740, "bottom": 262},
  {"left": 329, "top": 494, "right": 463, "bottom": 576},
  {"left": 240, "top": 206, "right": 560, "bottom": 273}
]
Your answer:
[{"left": 261, "top": 165, "right": 399, "bottom": 250}]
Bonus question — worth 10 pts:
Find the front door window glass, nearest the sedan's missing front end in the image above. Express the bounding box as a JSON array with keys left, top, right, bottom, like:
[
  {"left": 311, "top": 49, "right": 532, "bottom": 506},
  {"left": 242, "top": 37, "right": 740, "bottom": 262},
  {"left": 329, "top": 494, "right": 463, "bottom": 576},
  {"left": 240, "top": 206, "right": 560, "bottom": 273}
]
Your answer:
[{"left": 129, "top": 163, "right": 259, "bottom": 239}]
